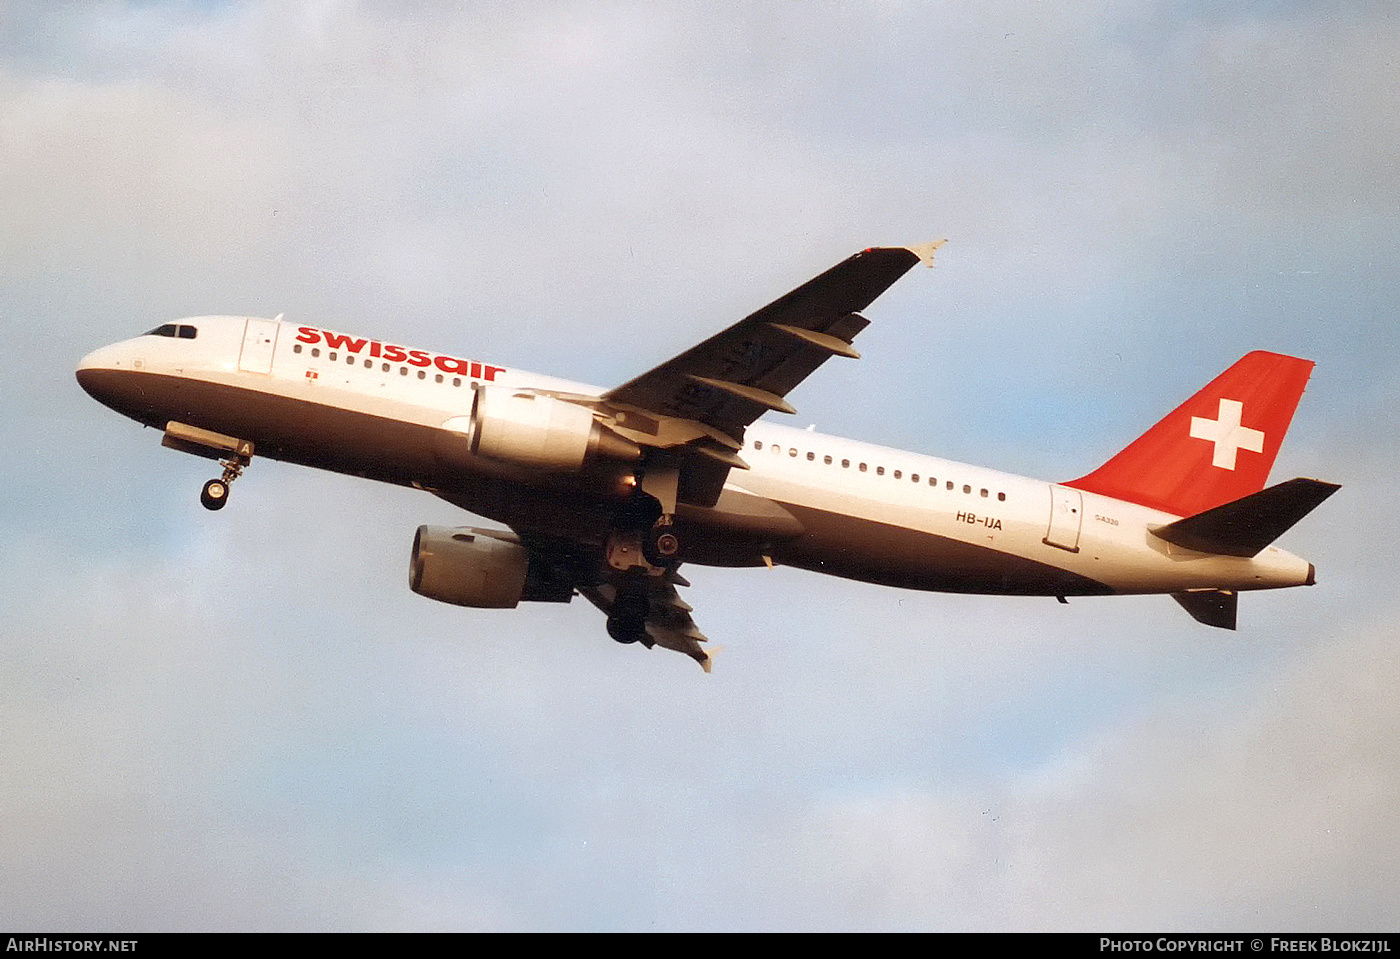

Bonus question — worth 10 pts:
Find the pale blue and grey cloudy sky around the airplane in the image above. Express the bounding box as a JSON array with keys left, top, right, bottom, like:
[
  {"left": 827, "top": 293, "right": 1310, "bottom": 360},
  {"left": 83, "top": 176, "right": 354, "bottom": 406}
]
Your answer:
[{"left": 0, "top": 0, "right": 1400, "bottom": 931}]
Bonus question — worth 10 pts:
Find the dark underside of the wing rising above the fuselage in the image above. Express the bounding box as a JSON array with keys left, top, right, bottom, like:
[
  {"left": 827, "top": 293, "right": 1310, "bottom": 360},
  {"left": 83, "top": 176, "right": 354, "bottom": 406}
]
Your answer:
[{"left": 603, "top": 241, "right": 944, "bottom": 442}]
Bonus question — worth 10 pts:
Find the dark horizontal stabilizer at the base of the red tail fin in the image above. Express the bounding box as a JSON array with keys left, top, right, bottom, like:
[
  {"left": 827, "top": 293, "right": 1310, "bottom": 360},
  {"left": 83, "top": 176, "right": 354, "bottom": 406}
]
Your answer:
[{"left": 1152, "top": 479, "right": 1341, "bottom": 557}]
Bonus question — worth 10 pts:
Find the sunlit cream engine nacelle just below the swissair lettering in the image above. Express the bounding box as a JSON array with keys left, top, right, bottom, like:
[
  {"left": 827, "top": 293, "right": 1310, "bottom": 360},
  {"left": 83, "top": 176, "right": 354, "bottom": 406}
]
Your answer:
[{"left": 468, "top": 386, "right": 641, "bottom": 472}]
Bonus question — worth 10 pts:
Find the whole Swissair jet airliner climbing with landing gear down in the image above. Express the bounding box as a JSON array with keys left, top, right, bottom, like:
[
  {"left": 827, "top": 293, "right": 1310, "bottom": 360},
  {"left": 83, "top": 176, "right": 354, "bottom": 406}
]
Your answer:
[{"left": 77, "top": 241, "right": 1338, "bottom": 672}]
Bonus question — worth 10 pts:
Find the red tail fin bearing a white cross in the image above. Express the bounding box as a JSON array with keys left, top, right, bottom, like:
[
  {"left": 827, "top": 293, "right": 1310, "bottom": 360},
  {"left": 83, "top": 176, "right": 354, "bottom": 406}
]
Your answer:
[{"left": 1065, "top": 350, "right": 1313, "bottom": 517}]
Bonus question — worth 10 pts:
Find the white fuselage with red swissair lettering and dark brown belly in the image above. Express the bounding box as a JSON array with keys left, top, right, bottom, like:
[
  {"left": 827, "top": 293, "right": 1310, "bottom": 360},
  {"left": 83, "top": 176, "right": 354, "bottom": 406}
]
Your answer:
[{"left": 80, "top": 316, "right": 1310, "bottom": 595}]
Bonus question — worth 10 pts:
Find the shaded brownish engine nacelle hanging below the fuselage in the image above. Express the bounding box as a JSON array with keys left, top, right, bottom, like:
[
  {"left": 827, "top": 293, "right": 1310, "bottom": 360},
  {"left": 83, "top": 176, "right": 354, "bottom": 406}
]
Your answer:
[{"left": 409, "top": 526, "right": 529, "bottom": 609}]
